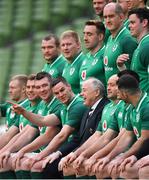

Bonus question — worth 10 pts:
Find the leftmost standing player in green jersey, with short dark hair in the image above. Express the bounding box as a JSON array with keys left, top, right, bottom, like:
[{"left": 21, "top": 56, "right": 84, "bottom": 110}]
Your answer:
[{"left": 41, "top": 34, "right": 66, "bottom": 78}]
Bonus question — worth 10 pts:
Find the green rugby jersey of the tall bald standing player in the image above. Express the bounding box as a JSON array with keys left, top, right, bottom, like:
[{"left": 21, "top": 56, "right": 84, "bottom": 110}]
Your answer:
[{"left": 104, "top": 27, "right": 137, "bottom": 82}]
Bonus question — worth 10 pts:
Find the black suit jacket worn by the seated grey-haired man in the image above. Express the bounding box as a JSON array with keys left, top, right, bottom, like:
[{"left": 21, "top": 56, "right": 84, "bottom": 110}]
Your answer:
[{"left": 59, "top": 97, "right": 109, "bottom": 156}]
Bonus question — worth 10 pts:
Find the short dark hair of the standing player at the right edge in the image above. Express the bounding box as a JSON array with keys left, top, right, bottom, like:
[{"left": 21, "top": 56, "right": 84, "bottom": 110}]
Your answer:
[{"left": 128, "top": 8, "right": 149, "bottom": 27}]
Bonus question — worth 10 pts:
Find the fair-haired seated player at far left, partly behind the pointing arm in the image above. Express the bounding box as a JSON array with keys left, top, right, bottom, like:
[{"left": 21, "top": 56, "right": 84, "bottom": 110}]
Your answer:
[{"left": 0, "top": 75, "right": 28, "bottom": 149}]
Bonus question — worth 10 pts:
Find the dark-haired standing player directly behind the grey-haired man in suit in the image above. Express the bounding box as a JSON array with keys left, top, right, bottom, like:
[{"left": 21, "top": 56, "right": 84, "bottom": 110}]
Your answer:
[{"left": 80, "top": 20, "right": 106, "bottom": 85}]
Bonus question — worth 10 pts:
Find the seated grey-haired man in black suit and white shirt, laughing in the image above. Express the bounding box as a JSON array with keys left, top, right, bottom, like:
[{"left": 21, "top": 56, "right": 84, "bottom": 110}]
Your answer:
[{"left": 43, "top": 78, "right": 109, "bottom": 179}]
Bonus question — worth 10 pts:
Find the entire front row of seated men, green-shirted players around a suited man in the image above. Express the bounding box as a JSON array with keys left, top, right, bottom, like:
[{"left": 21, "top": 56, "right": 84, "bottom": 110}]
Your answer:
[{"left": 0, "top": 70, "right": 149, "bottom": 179}]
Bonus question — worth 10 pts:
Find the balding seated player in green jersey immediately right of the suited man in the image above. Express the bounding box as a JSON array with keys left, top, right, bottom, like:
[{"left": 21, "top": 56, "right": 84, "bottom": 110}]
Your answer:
[{"left": 60, "top": 75, "right": 124, "bottom": 175}]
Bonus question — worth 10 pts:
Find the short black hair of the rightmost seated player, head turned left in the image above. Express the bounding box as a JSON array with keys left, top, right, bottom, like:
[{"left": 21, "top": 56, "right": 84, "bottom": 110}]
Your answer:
[{"left": 117, "top": 74, "right": 140, "bottom": 94}]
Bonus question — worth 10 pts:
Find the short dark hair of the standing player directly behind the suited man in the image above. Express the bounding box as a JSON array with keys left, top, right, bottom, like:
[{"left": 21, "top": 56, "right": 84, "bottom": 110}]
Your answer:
[{"left": 85, "top": 20, "right": 105, "bottom": 34}]
